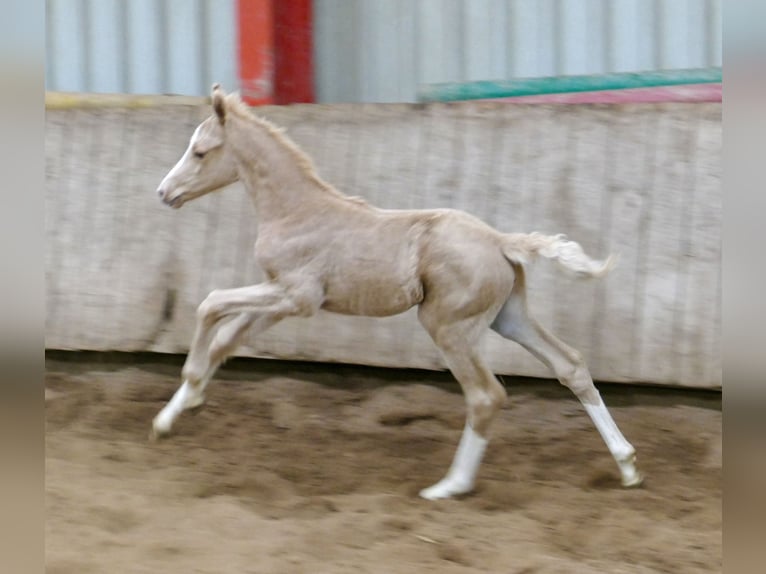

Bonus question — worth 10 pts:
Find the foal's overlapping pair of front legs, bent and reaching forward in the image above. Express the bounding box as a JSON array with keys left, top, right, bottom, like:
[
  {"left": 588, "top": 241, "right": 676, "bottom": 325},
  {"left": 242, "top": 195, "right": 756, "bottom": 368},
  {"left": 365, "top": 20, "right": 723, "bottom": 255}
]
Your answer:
[{"left": 151, "top": 283, "right": 319, "bottom": 438}]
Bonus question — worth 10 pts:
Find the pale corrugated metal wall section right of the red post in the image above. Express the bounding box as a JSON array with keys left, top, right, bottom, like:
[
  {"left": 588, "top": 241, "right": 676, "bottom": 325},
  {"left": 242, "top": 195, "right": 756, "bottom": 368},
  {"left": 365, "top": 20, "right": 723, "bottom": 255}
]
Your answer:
[{"left": 314, "top": 0, "right": 722, "bottom": 102}]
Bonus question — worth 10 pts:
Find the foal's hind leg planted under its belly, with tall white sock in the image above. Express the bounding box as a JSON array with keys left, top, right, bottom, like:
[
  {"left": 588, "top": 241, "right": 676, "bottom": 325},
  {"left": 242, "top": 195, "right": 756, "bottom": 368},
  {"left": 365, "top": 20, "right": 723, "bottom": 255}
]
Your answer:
[{"left": 418, "top": 306, "right": 506, "bottom": 500}]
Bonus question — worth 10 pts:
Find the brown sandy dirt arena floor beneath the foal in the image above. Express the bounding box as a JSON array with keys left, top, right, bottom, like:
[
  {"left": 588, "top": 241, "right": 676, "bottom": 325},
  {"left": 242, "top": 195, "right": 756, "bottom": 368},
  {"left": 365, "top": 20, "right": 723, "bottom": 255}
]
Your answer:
[{"left": 46, "top": 358, "right": 722, "bottom": 574}]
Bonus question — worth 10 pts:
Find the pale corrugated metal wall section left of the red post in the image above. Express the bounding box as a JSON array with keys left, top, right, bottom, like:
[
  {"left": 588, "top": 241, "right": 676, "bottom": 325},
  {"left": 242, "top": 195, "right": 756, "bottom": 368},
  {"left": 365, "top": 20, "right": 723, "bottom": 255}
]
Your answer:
[{"left": 45, "top": 0, "right": 238, "bottom": 95}]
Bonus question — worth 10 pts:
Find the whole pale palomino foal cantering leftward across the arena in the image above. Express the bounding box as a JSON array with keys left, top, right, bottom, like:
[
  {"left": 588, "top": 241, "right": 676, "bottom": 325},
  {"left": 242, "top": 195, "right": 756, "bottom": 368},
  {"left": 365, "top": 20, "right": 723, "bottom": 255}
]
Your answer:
[{"left": 152, "top": 84, "right": 641, "bottom": 499}]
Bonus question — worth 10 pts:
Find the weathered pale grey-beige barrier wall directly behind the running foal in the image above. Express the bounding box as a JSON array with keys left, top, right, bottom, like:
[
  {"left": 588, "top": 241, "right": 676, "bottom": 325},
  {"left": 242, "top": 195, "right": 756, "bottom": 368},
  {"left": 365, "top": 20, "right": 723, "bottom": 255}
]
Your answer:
[{"left": 45, "top": 98, "right": 722, "bottom": 387}]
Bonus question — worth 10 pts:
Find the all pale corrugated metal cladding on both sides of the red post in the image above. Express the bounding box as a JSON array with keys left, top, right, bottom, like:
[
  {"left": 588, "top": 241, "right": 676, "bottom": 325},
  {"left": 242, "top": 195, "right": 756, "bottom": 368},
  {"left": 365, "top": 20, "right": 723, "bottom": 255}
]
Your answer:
[{"left": 46, "top": 0, "right": 721, "bottom": 102}]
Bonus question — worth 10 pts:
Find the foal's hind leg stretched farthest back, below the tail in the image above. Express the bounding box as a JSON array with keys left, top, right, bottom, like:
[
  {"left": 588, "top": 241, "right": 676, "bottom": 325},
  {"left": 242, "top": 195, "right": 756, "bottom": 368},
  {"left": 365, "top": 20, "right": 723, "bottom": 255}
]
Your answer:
[{"left": 491, "top": 290, "right": 642, "bottom": 487}]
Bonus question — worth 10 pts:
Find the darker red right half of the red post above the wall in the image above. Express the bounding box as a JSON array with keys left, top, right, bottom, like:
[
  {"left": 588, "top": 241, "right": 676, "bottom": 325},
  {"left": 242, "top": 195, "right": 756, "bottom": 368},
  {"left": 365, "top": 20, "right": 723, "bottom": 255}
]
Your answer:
[{"left": 273, "top": 0, "right": 314, "bottom": 104}]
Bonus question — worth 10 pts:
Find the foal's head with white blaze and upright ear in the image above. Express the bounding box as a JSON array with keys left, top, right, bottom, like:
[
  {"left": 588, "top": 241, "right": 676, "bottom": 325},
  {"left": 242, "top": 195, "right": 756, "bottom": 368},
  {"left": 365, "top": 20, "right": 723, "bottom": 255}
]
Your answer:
[{"left": 157, "top": 84, "right": 239, "bottom": 208}]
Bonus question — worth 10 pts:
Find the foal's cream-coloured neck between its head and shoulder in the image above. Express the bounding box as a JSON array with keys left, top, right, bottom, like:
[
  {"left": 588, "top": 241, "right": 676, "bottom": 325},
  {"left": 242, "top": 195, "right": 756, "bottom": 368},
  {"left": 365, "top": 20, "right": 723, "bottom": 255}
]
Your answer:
[{"left": 229, "top": 118, "right": 331, "bottom": 220}]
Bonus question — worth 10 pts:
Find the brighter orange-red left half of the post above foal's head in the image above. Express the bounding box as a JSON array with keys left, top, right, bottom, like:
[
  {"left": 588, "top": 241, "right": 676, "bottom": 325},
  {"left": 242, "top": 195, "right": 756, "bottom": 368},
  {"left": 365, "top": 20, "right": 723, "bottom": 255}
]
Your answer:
[{"left": 237, "top": 0, "right": 279, "bottom": 106}]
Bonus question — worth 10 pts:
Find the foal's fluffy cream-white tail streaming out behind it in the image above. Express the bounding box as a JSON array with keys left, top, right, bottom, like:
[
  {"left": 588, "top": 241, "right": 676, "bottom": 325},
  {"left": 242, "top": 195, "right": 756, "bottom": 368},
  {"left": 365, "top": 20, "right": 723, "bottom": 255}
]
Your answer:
[{"left": 502, "top": 232, "right": 616, "bottom": 277}]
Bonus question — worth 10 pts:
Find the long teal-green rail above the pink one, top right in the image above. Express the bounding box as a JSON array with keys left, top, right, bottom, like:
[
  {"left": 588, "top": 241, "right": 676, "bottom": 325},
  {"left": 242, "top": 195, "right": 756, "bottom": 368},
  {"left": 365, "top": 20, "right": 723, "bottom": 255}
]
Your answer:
[{"left": 418, "top": 68, "right": 722, "bottom": 102}]
